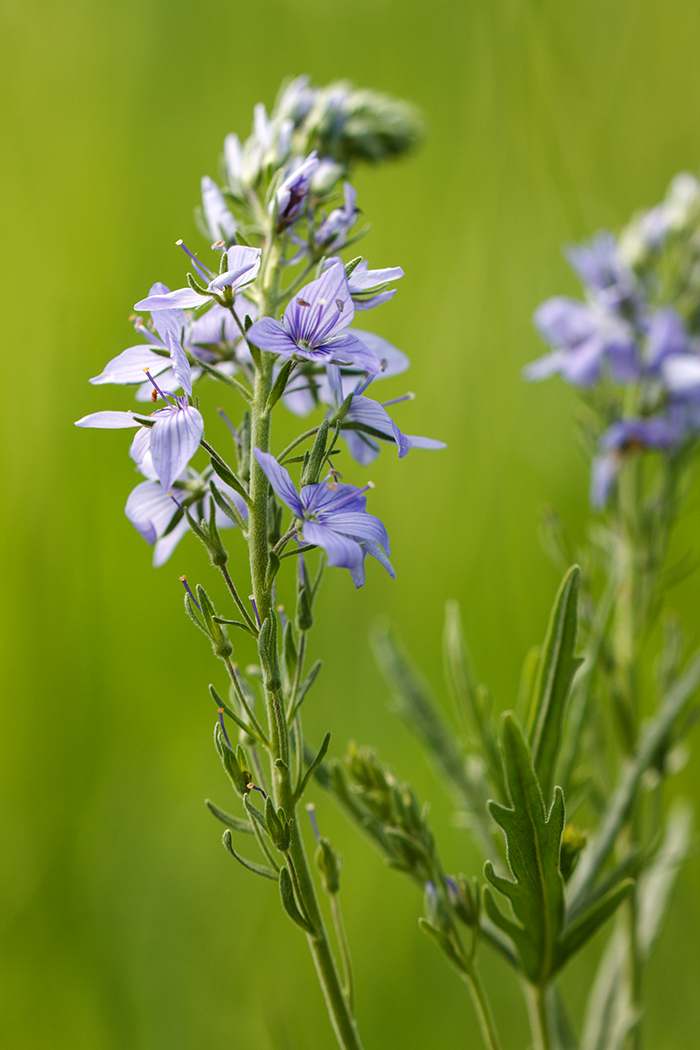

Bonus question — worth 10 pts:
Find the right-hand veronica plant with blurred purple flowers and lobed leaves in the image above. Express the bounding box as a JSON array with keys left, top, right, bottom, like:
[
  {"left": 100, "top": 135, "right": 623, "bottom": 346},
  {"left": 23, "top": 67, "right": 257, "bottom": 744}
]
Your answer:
[{"left": 325, "top": 168, "right": 700, "bottom": 1050}]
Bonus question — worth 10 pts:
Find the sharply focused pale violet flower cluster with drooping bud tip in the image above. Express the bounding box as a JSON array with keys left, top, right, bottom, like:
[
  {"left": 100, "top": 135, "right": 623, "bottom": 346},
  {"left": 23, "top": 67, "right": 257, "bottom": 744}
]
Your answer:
[{"left": 77, "top": 78, "right": 444, "bottom": 586}]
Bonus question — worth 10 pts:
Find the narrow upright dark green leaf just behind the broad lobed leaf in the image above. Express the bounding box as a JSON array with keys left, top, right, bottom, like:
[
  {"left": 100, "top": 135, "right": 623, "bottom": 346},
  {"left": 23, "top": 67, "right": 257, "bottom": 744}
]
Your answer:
[{"left": 528, "top": 565, "right": 582, "bottom": 801}]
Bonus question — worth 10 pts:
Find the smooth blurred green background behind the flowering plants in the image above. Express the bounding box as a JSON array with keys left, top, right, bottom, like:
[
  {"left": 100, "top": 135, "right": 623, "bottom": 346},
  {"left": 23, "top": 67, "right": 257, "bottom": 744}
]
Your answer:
[{"left": 0, "top": 0, "right": 700, "bottom": 1050}]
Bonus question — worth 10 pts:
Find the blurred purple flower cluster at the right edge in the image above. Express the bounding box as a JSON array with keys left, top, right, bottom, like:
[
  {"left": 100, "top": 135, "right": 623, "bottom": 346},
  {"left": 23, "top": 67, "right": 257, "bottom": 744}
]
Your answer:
[{"left": 525, "top": 174, "right": 700, "bottom": 507}]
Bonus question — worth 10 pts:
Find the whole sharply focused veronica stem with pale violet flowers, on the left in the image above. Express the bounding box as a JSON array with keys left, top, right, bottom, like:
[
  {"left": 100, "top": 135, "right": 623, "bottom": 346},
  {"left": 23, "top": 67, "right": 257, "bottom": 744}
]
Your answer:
[{"left": 77, "top": 78, "right": 443, "bottom": 1050}]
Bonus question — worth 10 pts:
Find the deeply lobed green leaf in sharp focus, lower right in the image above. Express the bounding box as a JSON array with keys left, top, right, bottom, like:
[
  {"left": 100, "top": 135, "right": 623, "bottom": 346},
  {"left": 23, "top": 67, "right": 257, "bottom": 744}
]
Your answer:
[{"left": 484, "top": 713, "right": 565, "bottom": 985}]
